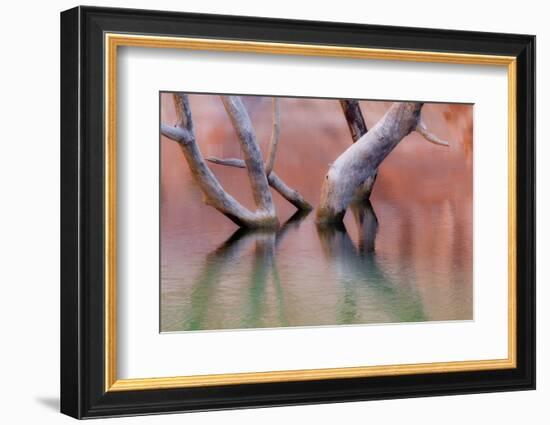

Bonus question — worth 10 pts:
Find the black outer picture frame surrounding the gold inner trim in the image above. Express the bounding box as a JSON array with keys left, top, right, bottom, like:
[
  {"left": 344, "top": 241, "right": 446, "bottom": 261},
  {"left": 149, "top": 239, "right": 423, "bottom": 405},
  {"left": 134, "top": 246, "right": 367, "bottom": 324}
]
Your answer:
[{"left": 61, "top": 7, "right": 535, "bottom": 418}]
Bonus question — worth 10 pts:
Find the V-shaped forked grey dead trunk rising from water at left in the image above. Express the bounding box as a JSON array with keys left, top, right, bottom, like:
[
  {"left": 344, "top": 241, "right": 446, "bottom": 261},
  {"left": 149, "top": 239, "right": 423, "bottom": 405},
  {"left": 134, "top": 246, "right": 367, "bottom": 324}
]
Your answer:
[{"left": 161, "top": 93, "right": 278, "bottom": 228}]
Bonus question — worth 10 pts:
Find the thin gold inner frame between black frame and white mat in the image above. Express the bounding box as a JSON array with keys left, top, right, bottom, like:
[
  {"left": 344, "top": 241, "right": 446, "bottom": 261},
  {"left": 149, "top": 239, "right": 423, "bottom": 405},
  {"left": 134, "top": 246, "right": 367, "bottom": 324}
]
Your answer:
[{"left": 104, "top": 33, "right": 517, "bottom": 391}]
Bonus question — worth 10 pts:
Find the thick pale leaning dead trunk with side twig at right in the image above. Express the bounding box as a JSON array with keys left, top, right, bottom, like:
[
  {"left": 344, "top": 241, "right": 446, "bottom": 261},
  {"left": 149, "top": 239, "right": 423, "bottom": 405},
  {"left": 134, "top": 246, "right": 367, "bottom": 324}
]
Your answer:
[{"left": 317, "top": 102, "right": 448, "bottom": 224}]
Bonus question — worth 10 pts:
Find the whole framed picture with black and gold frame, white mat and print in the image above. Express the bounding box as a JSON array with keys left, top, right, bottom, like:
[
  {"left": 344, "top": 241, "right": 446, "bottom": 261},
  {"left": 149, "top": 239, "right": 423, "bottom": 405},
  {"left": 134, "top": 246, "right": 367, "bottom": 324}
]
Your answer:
[{"left": 61, "top": 7, "right": 535, "bottom": 418}]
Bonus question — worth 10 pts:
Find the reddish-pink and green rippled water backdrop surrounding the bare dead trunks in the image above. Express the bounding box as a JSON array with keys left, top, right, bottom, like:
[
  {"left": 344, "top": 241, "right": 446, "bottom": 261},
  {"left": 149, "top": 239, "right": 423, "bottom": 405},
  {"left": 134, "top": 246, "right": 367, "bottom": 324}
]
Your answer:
[{"left": 160, "top": 95, "right": 472, "bottom": 331}]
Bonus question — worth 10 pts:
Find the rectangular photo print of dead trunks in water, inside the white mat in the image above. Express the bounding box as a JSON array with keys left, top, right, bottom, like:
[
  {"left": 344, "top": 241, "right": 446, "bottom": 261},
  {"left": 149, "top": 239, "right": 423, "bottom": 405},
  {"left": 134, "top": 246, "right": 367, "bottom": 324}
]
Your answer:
[{"left": 159, "top": 91, "right": 475, "bottom": 332}]
